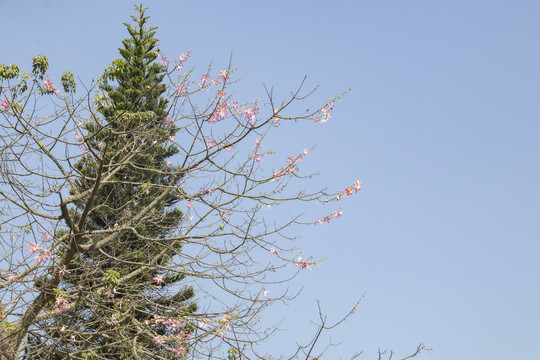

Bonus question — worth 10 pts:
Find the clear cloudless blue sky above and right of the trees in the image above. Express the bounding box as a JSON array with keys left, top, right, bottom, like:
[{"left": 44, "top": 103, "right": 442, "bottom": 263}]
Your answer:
[{"left": 0, "top": 0, "right": 540, "bottom": 360}]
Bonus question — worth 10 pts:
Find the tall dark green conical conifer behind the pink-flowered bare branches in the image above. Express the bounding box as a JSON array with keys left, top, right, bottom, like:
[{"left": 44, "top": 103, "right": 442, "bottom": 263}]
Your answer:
[{"left": 26, "top": 6, "right": 197, "bottom": 359}]
